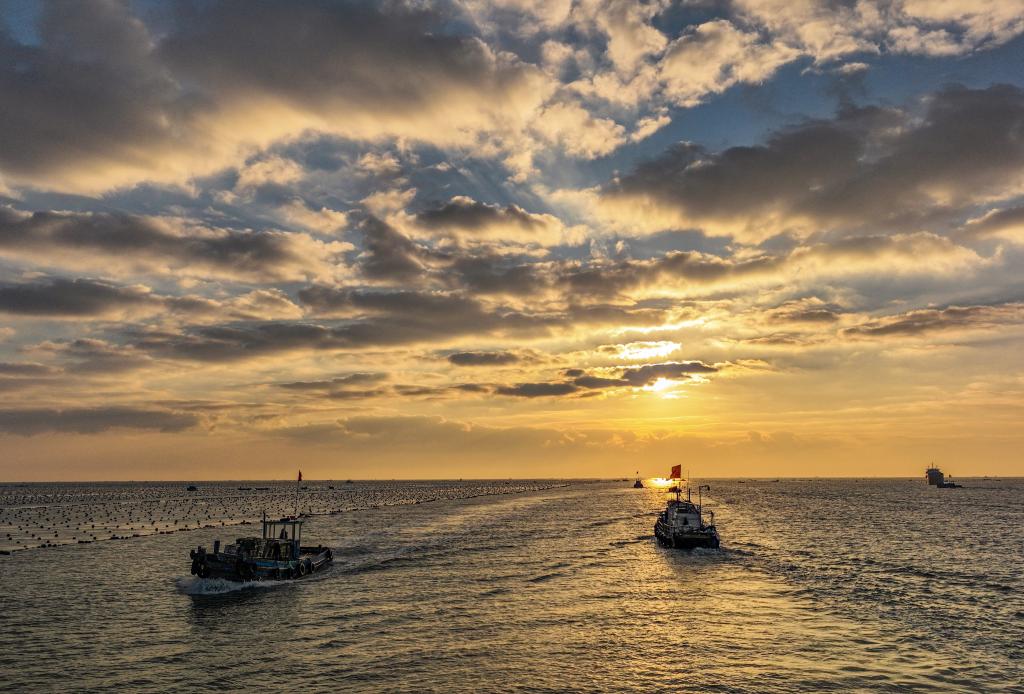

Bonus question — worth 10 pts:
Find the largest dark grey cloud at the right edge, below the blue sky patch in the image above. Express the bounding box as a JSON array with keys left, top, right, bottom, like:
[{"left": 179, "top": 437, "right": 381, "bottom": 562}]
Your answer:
[{"left": 604, "top": 85, "right": 1024, "bottom": 237}]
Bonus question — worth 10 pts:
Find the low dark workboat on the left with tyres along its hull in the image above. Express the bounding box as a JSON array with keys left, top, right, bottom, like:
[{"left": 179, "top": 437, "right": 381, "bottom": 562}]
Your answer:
[{"left": 188, "top": 513, "right": 334, "bottom": 581}]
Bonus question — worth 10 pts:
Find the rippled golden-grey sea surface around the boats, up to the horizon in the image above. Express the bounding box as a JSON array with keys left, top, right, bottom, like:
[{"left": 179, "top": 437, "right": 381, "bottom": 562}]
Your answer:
[{"left": 0, "top": 479, "right": 1024, "bottom": 692}]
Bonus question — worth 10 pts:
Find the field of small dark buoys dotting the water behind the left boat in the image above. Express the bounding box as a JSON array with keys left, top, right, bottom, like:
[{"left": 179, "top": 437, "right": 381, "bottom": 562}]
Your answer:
[{"left": 0, "top": 480, "right": 565, "bottom": 554}]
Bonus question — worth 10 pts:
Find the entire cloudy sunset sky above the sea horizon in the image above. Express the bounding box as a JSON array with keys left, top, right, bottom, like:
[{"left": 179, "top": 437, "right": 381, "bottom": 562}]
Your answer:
[{"left": 0, "top": 0, "right": 1024, "bottom": 481}]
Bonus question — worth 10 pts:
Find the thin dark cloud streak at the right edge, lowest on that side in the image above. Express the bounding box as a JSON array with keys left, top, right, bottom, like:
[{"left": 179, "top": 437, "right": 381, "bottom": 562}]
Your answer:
[{"left": 842, "top": 303, "right": 1024, "bottom": 338}]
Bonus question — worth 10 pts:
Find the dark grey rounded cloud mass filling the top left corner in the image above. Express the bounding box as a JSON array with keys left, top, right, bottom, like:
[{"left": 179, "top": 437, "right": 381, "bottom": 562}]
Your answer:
[{"left": 0, "top": 1, "right": 185, "bottom": 182}]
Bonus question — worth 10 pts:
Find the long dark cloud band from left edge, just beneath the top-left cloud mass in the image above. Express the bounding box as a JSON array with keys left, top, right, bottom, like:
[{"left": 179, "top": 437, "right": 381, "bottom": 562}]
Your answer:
[{"left": 0, "top": 207, "right": 333, "bottom": 281}]
